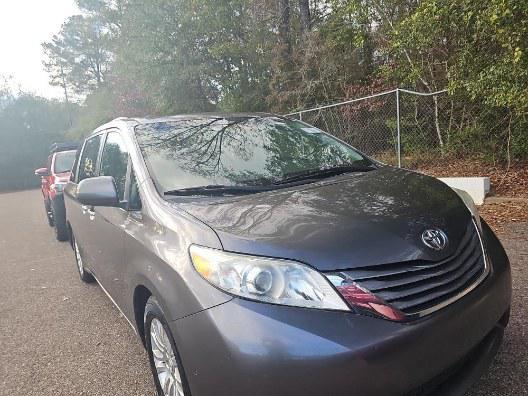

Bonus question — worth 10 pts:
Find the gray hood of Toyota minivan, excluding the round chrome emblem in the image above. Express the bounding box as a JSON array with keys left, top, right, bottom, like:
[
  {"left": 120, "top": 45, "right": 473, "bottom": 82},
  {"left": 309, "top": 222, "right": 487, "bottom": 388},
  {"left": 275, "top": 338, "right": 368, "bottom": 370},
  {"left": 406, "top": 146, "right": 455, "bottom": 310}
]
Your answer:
[{"left": 182, "top": 167, "right": 471, "bottom": 271}]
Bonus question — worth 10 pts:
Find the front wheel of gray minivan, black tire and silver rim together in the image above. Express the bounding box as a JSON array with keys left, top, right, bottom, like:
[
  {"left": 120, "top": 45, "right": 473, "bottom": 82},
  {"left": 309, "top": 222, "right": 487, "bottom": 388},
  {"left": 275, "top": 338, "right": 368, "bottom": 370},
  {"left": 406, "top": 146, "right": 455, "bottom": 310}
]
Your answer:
[{"left": 144, "top": 296, "right": 190, "bottom": 396}]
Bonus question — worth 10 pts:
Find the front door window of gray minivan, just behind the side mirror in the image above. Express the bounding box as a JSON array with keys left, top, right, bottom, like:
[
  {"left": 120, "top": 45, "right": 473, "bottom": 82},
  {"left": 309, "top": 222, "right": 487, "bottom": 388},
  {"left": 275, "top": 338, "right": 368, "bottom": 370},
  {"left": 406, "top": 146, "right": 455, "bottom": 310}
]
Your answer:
[{"left": 100, "top": 132, "right": 128, "bottom": 201}]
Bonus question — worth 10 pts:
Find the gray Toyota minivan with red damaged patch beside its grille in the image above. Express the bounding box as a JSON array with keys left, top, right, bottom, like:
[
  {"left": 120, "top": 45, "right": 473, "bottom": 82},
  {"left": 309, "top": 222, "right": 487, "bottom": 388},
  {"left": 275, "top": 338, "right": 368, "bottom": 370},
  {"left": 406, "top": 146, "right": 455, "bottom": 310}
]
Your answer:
[{"left": 65, "top": 114, "right": 511, "bottom": 396}]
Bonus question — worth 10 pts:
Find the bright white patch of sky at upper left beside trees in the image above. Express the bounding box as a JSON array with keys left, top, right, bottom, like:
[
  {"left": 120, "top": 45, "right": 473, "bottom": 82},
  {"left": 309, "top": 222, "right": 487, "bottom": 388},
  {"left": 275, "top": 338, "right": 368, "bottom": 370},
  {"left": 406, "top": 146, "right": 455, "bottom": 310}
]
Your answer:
[{"left": 0, "top": 0, "right": 78, "bottom": 98}]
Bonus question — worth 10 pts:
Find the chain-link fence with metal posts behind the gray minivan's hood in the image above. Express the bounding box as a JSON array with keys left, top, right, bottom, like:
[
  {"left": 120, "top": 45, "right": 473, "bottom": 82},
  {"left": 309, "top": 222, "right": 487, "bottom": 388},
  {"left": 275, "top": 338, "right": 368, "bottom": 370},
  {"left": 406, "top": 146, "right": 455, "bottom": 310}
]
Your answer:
[{"left": 288, "top": 89, "right": 507, "bottom": 169}]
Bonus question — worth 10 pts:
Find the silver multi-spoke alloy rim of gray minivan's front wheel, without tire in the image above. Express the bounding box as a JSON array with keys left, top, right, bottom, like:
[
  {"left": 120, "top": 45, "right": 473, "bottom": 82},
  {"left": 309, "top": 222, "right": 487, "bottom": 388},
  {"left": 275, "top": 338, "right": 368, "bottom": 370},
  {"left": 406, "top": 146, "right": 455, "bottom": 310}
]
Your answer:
[{"left": 150, "top": 318, "right": 184, "bottom": 396}]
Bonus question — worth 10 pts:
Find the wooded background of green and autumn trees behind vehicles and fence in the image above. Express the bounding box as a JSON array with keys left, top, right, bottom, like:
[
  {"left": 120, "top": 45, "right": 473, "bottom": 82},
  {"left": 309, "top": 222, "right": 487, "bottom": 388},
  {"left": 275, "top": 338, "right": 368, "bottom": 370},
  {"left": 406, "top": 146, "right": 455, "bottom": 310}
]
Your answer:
[{"left": 0, "top": 0, "right": 528, "bottom": 190}]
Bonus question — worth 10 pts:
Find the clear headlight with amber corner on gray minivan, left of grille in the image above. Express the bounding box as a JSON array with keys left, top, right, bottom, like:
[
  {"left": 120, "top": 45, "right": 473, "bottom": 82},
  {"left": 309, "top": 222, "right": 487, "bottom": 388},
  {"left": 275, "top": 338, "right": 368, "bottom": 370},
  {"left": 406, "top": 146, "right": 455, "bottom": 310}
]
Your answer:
[{"left": 189, "top": 245, "right": 350, "bottom": 311}]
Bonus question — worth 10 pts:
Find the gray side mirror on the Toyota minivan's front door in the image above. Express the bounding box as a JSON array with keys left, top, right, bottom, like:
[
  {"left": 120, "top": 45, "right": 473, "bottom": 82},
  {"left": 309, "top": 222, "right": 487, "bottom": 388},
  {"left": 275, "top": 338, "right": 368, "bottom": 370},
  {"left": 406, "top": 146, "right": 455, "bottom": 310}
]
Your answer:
[{"left": 77, "top": 176, "right": 119, "bottom": 206}]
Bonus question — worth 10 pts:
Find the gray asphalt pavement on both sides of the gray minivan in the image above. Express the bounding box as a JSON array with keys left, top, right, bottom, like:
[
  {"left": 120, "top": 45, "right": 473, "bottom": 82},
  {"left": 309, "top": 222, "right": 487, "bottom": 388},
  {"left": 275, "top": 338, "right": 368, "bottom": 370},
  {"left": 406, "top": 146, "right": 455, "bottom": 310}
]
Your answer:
[{"left": 0, "top": 191, "right": 528, "bottom": 396}]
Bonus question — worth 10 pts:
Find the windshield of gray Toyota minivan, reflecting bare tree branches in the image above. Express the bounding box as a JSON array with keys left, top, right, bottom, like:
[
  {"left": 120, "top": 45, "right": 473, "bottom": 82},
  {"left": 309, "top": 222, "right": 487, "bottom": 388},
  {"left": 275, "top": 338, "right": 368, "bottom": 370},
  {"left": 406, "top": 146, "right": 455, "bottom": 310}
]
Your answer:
[{"left": 136, "top": 117, "right": 372, "bottom": 192}]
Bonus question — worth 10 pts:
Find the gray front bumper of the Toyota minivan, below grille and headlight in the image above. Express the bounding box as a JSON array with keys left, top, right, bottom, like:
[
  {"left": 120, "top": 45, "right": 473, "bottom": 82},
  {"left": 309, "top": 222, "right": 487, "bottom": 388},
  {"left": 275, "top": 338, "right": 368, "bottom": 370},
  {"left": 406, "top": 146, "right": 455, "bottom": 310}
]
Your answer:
[{"left": 170, "top": 226, "right": 511, "bottom": 396}]
